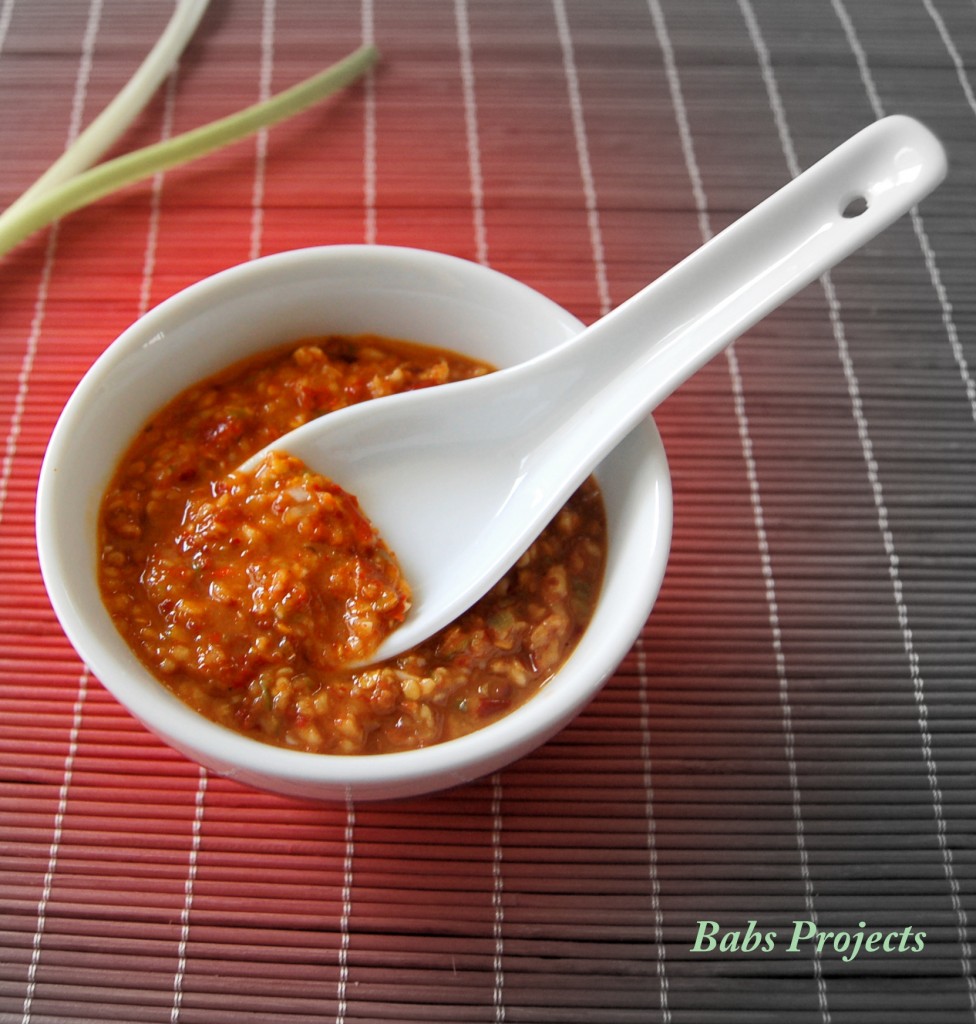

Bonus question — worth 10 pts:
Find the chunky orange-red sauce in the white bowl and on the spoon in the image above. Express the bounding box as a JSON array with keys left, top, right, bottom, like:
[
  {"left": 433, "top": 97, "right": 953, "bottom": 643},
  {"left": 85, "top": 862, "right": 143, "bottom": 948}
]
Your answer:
[{"left": 99, "top": 336, "right": 606, "bottom": 754}]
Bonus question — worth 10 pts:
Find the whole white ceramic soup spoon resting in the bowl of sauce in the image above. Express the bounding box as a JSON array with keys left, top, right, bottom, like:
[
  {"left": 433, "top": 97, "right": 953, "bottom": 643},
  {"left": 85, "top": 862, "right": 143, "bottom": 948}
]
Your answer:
[{"left": 244, "top": 116, "right": 946, "bottom": 662}]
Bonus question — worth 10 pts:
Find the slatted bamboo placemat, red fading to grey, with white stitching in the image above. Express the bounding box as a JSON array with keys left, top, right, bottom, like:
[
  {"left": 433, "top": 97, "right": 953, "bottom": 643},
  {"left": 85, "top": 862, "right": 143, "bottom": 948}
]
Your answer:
[{"left": 0, "top": 0, "right": 976, "bottom": 1024}]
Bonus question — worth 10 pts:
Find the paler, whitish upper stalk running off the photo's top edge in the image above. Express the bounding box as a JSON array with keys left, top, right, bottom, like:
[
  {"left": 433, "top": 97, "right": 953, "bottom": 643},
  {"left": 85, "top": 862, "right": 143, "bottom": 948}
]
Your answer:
[{"left": 7, "top": 0, "right": 210, "bottom": 216}]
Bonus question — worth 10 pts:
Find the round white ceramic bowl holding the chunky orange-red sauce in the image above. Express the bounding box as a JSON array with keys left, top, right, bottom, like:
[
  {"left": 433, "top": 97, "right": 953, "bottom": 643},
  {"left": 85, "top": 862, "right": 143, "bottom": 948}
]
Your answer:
[{"left": 37, "top": 246, "right": 672, "bottom": 800}]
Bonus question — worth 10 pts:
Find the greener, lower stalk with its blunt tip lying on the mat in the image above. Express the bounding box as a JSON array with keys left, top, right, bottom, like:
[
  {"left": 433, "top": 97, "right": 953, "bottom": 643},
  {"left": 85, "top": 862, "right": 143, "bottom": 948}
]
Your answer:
[{"left": 0, "top": 46, "right": 378, "bottom": 255}]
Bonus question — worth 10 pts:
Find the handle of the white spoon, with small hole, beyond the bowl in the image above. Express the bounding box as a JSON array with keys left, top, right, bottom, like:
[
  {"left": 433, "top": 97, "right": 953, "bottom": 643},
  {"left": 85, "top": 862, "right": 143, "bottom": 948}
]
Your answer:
[{"left": 528, "top": 116, "right": 946, "bottom": 465}]
